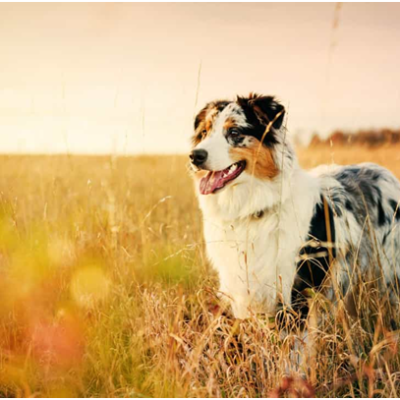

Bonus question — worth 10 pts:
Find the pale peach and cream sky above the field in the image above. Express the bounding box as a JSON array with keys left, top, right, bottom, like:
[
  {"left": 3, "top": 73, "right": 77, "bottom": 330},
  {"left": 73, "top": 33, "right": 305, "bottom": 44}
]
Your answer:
[{"left": 0, "top": 3, "right": 400, "bottom": 154}]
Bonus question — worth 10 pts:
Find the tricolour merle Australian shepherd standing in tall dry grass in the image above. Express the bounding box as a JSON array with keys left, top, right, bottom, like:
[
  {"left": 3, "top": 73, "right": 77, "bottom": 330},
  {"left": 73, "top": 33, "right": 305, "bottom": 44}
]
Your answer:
[{"left": 190, "top": 94, "right": 400, "bottom": 319}]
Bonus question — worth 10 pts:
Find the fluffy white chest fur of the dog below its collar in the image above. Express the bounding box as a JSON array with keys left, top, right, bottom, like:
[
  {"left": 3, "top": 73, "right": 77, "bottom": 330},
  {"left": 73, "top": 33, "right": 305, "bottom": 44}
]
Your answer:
[{"left": 200, "top": 169, "right": 315, "bottom": 318}]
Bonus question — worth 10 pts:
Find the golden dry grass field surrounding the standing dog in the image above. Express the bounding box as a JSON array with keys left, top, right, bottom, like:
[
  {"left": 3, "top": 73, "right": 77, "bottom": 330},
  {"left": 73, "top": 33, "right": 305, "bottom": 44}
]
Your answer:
[{"left": 0, "top": 147, "right": 400, "bottom": 397}]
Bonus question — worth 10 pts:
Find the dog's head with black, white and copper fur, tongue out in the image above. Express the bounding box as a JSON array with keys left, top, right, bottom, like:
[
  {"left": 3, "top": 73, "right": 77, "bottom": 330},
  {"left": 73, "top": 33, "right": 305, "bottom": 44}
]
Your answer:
[{"left": 190, "top": 94, "right": 285, "bottom": 195}]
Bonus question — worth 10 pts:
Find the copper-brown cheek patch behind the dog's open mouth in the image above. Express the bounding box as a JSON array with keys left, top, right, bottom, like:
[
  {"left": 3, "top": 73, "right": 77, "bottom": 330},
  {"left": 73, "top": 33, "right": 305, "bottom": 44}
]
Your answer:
[{"left": 229, "top": 140, "right": 279, "bottom": 179}]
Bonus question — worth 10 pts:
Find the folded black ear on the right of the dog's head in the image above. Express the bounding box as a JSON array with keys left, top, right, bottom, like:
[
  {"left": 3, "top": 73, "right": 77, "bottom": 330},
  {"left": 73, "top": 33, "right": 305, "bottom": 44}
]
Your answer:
[{"left": 248, "top": 94, "right": 285, "bottom": 129}]
